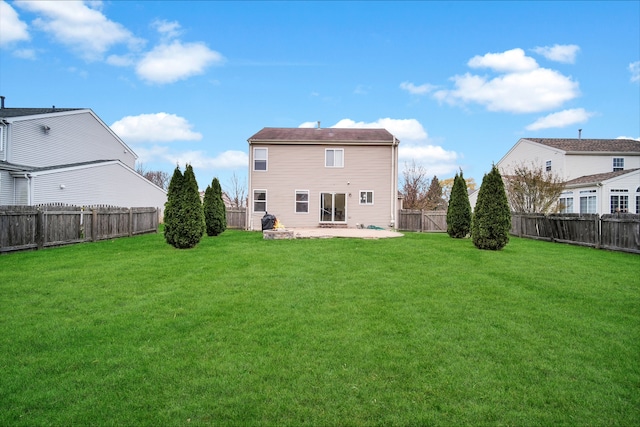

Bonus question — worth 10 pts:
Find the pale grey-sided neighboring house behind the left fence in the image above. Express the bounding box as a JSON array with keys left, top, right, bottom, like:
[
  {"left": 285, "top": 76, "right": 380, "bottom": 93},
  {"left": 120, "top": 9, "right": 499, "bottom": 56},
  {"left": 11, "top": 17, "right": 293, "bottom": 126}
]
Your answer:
[{"left": 0, "top": 97, "right": 167, "bottom": 210}]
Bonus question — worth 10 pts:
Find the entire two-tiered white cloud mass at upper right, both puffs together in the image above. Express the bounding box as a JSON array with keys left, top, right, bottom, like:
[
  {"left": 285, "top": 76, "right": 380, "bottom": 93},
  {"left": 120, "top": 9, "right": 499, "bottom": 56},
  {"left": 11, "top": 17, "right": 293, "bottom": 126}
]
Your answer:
[{"left": 433, "top": 49, "right": 579, "bottom": 113}]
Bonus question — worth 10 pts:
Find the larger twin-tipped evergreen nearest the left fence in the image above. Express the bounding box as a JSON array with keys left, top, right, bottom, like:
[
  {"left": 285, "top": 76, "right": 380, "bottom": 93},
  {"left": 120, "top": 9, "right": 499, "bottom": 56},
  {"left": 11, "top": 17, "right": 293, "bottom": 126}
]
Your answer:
[{"left": 165, "top": 165, "right": 205, "bottom": 249}]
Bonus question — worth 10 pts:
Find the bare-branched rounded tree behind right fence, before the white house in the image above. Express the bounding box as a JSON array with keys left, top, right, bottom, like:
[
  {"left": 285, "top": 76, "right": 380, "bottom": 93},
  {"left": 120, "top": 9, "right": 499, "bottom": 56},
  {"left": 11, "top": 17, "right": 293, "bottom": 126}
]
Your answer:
[{"left": 503, "top": 163, "right": 564, "bottom": 213}]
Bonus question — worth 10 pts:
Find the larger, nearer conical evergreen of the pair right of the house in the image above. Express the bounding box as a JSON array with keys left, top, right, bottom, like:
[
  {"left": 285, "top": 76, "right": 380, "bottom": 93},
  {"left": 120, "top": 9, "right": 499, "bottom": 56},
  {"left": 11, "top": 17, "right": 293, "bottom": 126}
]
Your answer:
[{"left": 471, "top": 165, "right": 511, "bottom": 250}]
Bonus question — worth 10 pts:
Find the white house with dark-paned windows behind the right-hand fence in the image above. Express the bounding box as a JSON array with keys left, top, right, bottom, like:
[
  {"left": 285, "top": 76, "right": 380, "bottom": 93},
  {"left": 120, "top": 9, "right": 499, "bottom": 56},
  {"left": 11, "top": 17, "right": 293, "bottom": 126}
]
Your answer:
[{"left": 470, "top": 138, "right": 640, "bottom": 215}]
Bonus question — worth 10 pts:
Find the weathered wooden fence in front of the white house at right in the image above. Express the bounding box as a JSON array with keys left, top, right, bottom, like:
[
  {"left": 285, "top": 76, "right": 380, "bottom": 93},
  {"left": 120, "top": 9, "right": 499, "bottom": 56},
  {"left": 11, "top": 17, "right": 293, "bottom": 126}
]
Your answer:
[{"left": 511, "top": 213, "right": 640, "bottom": 254}]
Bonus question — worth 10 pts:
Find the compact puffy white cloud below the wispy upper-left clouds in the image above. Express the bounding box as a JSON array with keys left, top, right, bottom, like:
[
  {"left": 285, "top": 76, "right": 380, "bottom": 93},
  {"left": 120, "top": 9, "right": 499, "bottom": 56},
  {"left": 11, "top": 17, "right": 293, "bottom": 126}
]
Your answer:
[{"left": 136, "top": 40, "right": 224, "bottom": 84}]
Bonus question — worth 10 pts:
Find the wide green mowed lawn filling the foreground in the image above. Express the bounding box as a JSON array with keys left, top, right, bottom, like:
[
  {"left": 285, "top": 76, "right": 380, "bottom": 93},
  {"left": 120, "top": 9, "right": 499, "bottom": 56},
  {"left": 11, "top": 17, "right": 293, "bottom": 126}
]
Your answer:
[{"left": 0, "top": 230, "right": 640, "bottom": 426}]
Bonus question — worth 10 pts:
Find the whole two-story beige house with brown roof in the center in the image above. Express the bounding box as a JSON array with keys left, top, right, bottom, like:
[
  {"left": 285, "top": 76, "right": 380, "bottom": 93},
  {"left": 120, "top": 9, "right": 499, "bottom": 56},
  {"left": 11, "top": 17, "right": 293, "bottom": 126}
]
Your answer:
[{"left": 248, "top": 126, "right": 400, "bottom": 230}]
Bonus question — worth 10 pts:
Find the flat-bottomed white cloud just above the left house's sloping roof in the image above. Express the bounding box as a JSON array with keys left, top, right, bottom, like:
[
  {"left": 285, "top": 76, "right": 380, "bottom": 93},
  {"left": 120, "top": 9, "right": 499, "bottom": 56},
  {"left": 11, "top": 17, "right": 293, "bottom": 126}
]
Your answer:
[{"left": 111, "top": 113, "right": 202, "bottom": 143}]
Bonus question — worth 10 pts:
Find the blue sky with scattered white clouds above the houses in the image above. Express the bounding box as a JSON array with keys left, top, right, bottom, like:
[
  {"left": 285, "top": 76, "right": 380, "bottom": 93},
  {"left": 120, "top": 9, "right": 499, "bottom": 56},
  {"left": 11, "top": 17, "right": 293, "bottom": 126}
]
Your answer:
[{"left": 0, "top": 0, "right": 640, "bottom": 189}]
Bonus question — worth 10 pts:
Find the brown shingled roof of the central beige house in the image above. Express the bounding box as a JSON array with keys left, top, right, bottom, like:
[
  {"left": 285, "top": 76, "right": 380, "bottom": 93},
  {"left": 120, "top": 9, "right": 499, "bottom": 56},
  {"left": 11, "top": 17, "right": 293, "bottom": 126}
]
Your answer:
[{"left": 248, "top": 128, "right": 400, "bottom": 144}]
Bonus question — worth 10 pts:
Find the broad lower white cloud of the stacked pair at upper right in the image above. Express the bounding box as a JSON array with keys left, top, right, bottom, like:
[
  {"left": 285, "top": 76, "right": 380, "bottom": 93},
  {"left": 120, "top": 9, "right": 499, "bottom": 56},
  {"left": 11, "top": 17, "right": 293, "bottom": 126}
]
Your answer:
[{"left": 434, "top": 68, "right": 579, "bottom": 113}]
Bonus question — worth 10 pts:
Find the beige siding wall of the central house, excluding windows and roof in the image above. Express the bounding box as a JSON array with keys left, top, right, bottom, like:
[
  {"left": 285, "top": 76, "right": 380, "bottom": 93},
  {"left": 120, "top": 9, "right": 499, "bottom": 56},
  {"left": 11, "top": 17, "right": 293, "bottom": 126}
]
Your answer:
[{"left": 249, "top": 145, "right": 397, "bottom": 229}]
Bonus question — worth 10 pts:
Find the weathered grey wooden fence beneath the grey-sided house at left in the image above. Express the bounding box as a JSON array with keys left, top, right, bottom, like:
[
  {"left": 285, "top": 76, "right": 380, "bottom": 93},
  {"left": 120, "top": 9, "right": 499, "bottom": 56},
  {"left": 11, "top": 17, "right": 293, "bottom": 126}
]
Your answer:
[{"left": 0, "top": 206, "right": 158, "bottom": 252}]
